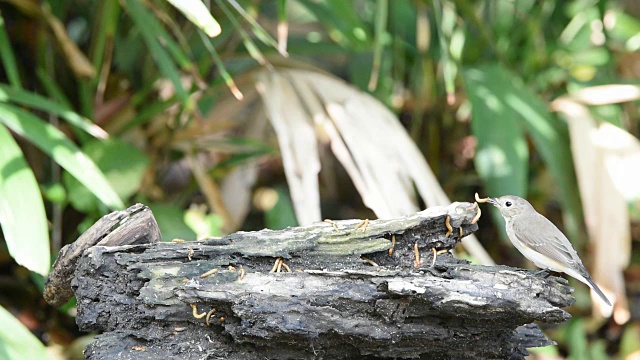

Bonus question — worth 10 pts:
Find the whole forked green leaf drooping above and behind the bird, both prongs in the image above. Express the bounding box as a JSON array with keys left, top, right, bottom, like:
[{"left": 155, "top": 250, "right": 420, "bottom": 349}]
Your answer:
[{"left": 465, "top": 64, "right": 581, "bottom": 245}]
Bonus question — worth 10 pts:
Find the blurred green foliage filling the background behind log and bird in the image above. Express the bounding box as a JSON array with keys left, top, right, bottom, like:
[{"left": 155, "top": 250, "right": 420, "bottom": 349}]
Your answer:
[{"left": 0, "top": 0, "right": 640, "bottom": 359}]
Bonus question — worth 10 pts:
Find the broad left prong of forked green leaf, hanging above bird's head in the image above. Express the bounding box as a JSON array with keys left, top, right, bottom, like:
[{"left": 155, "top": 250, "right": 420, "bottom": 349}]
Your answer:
[{"left": 464, "top": 67, "right": 529, "bottom": 196}]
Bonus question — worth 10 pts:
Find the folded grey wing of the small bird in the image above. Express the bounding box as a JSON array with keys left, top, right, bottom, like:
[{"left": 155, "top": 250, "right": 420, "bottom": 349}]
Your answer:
[{"left": 512, "top": 213, "right": 584, "bottom": 272}]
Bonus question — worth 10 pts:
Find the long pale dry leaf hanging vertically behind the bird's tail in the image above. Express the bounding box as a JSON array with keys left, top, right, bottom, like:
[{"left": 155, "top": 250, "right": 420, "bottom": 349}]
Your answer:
[{"left": 552, "top": 98, "right": 631, "bottom": 324}]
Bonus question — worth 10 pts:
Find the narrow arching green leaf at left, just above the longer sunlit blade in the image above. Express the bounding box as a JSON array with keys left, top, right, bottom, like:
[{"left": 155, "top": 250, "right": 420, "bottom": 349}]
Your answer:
[{"left": 0, "top": 84, "right": 109, "bottom": 139}]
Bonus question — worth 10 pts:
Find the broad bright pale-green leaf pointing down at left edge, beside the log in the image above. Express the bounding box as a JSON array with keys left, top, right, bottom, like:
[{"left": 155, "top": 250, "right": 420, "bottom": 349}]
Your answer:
[{"left": 0, "top": 125, "right": 51, "bottom": 275}]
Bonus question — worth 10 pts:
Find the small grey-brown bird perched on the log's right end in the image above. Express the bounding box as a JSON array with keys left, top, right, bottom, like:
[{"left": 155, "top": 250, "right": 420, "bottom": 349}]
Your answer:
[{"left": 486, "top": 195, "right": 611, "bottom": 306}]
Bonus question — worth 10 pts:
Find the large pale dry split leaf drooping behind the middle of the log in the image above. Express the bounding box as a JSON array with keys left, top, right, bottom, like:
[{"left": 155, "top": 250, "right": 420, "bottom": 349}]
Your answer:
[{"left": 252, "top": 68, "right": 493, "bottom": 264}]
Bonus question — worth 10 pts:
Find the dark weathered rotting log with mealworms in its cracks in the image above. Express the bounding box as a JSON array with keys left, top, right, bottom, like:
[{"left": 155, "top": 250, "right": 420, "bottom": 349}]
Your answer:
[{"left": 49, "top": 203, "right": 574, "bottom": 359}]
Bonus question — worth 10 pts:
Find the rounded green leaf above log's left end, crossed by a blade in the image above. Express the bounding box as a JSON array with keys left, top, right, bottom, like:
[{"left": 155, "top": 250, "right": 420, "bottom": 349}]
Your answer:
[{"left": 62, "top": 139, "right": 149, "bottom": 212}]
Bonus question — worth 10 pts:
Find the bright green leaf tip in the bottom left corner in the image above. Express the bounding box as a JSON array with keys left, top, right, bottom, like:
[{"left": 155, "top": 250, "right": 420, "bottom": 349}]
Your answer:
[{"left": 0, "top": 304, "right": 49, "bottom": 360}]
